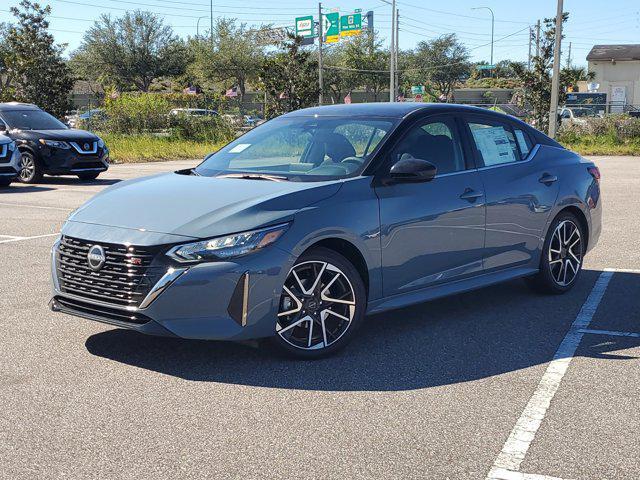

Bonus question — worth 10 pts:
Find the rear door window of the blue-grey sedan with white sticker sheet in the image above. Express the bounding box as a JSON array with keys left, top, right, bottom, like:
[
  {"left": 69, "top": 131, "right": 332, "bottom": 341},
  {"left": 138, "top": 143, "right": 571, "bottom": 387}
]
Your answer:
[{"left": 468, "top": 122, "right": 522, "bottom": 167}]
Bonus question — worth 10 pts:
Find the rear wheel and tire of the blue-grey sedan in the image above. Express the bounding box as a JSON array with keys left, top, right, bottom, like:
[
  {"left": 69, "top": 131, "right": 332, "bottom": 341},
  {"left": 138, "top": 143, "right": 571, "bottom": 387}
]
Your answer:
[{"left": 526, "top": 212, "right": 586, "bottom": 295}]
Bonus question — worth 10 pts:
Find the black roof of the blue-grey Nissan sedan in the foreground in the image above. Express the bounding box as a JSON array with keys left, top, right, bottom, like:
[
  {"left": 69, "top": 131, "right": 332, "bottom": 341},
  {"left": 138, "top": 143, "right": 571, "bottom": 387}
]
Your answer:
[{"left": 283, "top": 102, "right": 516, "bottom": 118}]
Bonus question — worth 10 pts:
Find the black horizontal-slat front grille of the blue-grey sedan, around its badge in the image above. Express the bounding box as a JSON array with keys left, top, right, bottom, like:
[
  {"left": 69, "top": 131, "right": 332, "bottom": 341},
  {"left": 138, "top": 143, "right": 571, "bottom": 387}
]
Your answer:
[{"left": 56, "top": 236, "right": 166, "bottom": 307}]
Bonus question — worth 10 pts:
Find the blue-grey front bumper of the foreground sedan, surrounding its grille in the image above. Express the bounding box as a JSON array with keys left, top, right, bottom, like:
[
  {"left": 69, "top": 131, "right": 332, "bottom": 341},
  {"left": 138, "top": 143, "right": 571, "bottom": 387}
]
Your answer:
[{"left": 50, "top": 225, "right": 293, "bottom": 340}]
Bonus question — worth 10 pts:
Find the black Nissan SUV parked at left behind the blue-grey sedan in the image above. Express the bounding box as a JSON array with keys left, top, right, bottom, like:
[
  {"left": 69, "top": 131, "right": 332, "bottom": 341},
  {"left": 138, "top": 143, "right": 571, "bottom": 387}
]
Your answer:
[{"left": 0, "top": 102, "right": 109, "bottom": 183}]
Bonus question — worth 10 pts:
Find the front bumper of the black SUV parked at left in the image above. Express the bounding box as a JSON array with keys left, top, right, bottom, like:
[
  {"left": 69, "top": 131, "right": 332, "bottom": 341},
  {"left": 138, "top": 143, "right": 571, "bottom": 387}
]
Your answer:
[{"left": 37, "top": 145, "right": 109, "bottom": 175}]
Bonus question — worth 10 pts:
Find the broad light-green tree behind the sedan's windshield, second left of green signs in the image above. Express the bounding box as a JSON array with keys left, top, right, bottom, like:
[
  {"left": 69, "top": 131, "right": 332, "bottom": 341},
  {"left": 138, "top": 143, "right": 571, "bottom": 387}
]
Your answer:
[{"left": 192, "top": 18, "right": 264, "bottom": 101}]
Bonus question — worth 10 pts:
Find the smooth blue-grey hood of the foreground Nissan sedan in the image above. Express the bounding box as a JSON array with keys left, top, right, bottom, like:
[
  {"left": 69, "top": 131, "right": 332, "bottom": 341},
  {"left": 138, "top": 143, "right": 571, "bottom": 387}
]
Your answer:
[{"left": 69, "top": 173, "right": 341, "bottom": 238}]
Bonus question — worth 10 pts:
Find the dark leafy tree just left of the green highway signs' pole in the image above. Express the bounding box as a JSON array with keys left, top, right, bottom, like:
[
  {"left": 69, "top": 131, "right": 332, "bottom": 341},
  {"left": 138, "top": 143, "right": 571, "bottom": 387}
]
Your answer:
[{"left": 260, "top": 35, "right": 320, "bottom": 118}]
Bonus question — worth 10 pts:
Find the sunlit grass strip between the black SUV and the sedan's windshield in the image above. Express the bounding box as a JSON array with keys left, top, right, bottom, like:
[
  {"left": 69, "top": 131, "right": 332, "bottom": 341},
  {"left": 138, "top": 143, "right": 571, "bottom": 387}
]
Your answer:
[{"left": 100, "top": 133, "right": 229, "bottom": 163}]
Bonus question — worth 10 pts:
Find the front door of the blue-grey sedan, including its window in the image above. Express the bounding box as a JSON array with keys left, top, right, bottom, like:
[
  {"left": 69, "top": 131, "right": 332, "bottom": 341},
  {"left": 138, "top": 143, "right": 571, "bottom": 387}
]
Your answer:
[{"left": 376, "top": 116, "right": 485, "bottom": 296}]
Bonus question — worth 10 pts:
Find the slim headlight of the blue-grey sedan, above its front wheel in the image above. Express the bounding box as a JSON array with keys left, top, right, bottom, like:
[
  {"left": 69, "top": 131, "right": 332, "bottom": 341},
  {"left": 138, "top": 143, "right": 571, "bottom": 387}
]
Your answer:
[{"left": 167, "top": 223, "right": 289, "bottom": 263}]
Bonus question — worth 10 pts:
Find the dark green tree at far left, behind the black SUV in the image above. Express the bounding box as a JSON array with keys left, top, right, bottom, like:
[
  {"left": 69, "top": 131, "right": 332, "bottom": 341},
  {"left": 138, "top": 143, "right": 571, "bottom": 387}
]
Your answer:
[{"left": 0, "top": 0, "right": 73, "bottom": 116}]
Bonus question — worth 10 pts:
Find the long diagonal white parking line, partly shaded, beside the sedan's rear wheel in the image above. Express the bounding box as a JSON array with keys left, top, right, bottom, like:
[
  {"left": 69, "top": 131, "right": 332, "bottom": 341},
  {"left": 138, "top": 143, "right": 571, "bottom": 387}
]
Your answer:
[{"left": 487, "top": 270, "right": 613, "bottom": 480}]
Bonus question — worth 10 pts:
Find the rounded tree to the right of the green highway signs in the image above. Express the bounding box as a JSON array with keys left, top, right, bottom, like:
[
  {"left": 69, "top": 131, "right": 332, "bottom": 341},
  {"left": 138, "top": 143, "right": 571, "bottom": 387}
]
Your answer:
[{"left": 410, "top": 33, "right": 470, "bottom": 98}]
